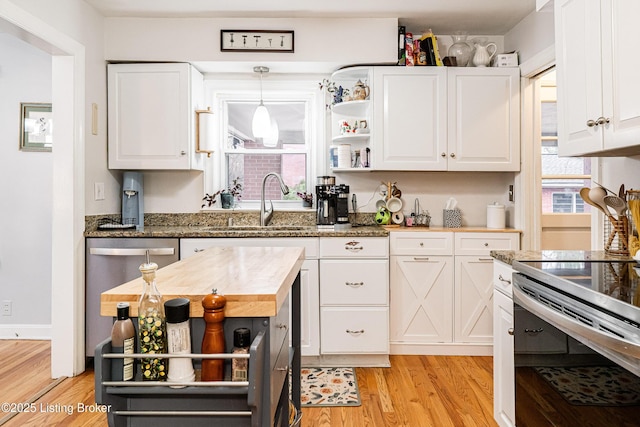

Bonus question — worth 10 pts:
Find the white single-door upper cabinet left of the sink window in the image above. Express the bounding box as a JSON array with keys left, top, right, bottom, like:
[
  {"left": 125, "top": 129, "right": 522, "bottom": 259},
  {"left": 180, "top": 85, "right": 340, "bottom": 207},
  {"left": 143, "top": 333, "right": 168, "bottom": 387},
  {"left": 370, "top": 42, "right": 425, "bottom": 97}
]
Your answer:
[{"left": 108, "top": 63, "right": 206, "bottom": 170}]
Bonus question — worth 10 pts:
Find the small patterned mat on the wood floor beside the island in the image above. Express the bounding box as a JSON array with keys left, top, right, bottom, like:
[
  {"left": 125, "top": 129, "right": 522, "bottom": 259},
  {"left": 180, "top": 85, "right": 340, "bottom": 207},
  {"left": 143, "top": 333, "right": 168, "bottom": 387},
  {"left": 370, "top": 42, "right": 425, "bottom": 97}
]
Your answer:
[{"left": 300, "top": 368, "right": 360, "bottom": 407}]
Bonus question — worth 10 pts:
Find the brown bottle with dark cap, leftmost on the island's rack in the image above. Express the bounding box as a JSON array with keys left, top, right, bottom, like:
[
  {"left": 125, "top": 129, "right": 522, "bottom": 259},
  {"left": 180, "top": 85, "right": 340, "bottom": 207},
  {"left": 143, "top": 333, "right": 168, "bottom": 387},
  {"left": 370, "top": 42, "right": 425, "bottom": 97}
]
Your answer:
[{"left": 111, "top": 302, "right": 136, "bottom": 381}]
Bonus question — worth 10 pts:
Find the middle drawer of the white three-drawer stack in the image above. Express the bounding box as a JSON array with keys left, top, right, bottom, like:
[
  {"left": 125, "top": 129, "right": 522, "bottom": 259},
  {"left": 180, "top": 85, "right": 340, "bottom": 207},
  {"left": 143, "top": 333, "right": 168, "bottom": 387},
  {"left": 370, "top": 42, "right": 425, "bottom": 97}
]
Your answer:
[{"left": 320, "top": 259, "right": 389, "bottom": 305}]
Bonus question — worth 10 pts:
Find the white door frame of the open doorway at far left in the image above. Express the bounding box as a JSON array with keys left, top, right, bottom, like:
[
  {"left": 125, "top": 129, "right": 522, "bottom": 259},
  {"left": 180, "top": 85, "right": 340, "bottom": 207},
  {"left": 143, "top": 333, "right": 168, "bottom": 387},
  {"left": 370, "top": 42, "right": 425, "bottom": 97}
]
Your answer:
[{"left": 0, "top": 2, "right": 85, "bottom": 378}]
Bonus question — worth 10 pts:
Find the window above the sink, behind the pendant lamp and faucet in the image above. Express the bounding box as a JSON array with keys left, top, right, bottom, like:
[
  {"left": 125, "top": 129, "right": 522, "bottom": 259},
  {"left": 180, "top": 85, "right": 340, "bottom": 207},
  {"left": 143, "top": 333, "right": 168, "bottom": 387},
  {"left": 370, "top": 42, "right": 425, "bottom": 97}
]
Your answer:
[{"left": 206, "top": 81, "right": 324, "bottom": 208}]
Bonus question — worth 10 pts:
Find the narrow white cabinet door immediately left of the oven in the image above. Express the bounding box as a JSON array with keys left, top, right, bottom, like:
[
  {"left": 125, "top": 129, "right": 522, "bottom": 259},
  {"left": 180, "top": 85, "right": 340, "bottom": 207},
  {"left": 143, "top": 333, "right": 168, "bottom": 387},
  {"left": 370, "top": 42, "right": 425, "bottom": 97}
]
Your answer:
[{"left": 493, "top": 290, "right": 516, "bottom": 427}]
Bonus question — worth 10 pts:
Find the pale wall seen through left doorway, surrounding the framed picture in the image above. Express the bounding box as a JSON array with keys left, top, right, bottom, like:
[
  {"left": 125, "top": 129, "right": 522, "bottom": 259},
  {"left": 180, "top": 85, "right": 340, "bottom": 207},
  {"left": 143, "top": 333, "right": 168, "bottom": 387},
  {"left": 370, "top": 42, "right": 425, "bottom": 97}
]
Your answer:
[{"left": 0, "top": 33, "right": 55, "bottom": 338}]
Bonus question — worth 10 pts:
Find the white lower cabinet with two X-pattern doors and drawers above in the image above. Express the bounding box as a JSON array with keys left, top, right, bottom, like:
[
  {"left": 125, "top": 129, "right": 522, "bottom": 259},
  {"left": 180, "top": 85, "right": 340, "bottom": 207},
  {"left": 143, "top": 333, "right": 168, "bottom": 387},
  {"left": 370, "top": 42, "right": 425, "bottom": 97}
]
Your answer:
[{"left": 389, "top": 231, "right": 519, "bottom": 355}]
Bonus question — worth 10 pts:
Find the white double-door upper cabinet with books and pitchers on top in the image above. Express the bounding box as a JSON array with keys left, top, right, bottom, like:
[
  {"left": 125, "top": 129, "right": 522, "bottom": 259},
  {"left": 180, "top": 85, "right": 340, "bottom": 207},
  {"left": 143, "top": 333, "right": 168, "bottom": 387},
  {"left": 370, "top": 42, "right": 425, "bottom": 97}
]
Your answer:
[{"left": 372, "top": 67, "right": 520, "bottom": 171}]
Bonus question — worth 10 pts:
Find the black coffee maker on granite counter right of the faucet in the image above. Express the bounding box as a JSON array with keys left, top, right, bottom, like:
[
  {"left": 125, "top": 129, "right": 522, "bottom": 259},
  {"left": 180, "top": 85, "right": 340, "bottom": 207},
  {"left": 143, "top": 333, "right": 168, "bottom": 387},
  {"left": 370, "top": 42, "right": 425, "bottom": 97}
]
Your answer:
[{"left": 316, "top": 176, "right": 351, "bottom": 230}]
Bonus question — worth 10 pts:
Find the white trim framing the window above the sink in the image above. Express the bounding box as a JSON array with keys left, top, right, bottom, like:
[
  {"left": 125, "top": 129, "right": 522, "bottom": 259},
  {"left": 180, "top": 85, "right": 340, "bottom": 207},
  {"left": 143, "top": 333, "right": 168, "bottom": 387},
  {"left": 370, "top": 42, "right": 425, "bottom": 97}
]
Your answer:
[{"left": 202, "top": 74, "right": 326, "bottom": 211}]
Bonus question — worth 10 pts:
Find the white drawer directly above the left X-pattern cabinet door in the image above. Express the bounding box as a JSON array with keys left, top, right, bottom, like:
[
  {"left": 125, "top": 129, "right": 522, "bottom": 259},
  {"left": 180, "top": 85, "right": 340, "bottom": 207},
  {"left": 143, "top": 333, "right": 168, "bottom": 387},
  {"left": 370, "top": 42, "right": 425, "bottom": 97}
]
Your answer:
[{"left": 389, "top": 231, "right": 453, "bottom": 255}]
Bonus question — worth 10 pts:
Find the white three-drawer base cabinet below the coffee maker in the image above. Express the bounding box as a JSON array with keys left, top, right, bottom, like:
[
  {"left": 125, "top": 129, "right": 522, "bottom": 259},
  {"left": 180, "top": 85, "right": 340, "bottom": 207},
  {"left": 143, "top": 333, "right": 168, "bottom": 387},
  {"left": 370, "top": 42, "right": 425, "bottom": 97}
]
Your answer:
[{"left": 320, "top": 237, "right": 389, "bottom": 355}]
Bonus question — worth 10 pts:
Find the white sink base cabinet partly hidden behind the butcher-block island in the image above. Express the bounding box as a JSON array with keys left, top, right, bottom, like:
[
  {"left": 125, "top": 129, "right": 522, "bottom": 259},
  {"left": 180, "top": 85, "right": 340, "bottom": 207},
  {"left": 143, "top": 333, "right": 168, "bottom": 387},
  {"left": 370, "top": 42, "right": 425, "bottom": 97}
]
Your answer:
[{"left": 180, "top": 237, "right": 320, "bottom": 356}]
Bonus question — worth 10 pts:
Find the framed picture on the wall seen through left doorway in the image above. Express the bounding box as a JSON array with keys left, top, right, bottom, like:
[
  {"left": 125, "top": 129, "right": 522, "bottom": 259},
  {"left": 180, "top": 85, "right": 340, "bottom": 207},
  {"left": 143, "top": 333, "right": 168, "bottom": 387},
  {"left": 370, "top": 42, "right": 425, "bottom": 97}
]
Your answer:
[{"left": 20, "top": 102, "right": 53, "bottom": 151}]
